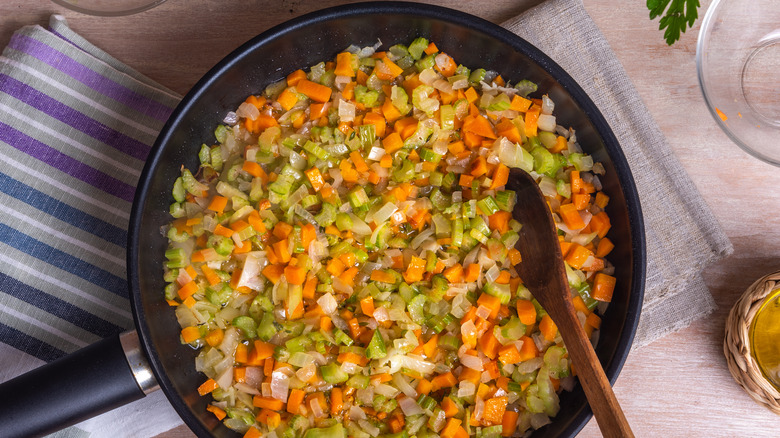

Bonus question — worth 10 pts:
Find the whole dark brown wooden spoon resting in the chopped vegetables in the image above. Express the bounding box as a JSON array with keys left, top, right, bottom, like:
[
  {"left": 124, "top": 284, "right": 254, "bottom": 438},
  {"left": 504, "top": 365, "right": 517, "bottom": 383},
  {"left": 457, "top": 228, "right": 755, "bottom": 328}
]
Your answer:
[{"left": 506, "top": 169, "right": 634, "bottom": 437}]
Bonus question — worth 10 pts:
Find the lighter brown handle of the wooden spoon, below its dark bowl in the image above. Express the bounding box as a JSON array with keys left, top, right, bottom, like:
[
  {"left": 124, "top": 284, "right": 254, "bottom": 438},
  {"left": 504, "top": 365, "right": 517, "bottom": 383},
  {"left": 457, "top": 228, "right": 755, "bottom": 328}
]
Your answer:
[{"left": 556, "top": 309, "right": 634, "bottom": 438}]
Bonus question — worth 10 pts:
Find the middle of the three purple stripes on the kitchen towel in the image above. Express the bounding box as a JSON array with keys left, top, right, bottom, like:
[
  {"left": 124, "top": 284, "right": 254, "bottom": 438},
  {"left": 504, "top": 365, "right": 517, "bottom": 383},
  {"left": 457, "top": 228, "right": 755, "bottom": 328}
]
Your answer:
[{"left": 0, "top": 74, "right": 151, "bottom": 160}]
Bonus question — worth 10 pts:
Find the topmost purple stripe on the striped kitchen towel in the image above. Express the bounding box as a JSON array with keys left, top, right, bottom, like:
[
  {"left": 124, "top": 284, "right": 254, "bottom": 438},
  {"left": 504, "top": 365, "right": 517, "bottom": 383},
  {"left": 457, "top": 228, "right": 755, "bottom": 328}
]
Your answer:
[{"left": 8, "top": 33, "right": 171, "bottom": 122}]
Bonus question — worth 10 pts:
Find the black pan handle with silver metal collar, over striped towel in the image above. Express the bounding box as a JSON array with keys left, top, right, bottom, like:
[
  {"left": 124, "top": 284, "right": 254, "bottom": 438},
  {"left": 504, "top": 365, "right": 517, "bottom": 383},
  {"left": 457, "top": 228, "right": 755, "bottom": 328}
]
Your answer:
[{"left": 0, "top": 332, "right": 158, "bottom": 437}]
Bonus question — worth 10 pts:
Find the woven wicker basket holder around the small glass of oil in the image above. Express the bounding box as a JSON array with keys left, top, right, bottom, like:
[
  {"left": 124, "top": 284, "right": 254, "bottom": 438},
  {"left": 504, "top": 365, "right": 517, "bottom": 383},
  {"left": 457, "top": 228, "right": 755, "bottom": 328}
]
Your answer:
[{"left": 723, "top": 271, "right": 780, "bottom": 414}]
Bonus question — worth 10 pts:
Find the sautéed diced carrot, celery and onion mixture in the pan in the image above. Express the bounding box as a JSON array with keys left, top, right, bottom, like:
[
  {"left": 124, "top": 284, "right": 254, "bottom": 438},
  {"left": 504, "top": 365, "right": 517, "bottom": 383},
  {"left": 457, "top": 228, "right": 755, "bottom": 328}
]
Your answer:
[{"left": 165, "top": 38, "right": 615, "bottom": 438}]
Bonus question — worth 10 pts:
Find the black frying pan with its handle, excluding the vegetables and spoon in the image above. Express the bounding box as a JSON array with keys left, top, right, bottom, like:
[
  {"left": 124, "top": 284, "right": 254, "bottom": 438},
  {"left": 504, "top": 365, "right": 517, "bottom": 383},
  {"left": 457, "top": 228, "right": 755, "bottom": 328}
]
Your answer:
[{"left": 0, "top": 3, "right": 645, "bottom": 437}]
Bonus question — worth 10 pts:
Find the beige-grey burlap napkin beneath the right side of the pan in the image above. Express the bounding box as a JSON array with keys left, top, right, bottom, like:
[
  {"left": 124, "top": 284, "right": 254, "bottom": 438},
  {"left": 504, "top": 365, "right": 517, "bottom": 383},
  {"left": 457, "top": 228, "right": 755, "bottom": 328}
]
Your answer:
[{"left": 502, "top": 0, "right": 733, "bottom": 348}]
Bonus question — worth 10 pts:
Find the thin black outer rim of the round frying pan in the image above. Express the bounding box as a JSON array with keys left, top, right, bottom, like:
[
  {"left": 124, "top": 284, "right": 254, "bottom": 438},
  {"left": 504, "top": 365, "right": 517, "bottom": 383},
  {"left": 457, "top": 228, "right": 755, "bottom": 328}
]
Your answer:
[{"left": 127, "top": 2, "right": 646, "bottom": 436}]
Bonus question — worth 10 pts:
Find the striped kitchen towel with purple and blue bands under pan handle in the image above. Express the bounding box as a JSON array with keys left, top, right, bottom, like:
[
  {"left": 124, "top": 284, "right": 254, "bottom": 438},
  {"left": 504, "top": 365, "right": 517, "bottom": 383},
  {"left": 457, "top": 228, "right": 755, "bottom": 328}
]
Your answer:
[{"left": 0, "top": 15, "right": 186, "bottom": 436}]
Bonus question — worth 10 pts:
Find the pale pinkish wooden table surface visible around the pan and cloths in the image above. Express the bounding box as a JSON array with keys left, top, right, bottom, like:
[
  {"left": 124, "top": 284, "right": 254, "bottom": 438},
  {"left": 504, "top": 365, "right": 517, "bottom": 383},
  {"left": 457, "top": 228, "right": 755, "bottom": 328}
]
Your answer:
[{"left": 6, "top": 0, "right": 780, "bottom": 438}]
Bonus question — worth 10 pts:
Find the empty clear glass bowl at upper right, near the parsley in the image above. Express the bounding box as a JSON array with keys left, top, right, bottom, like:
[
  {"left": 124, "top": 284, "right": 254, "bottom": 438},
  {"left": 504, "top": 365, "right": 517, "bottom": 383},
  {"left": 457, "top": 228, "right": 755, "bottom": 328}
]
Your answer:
[{"left": 696, "top": 0, "right": 780, "bottom": 166}]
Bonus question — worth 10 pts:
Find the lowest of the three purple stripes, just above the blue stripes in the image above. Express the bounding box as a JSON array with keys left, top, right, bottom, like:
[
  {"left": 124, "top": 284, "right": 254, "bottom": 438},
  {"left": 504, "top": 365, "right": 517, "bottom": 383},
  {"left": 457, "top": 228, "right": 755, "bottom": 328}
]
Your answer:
[{"left": 0, "top": 122, "right": 135, "bottom": 202}]
